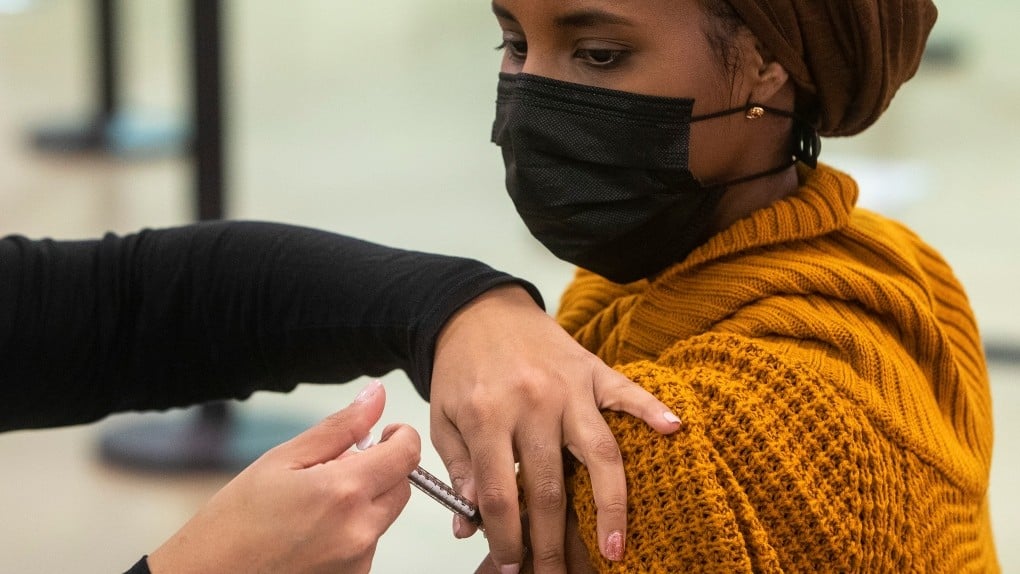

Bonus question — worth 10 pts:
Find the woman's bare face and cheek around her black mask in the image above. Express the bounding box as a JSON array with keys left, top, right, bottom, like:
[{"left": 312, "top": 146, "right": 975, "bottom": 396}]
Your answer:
[{"left": 493, "top": 0, "right": 775, "bottom": 186}]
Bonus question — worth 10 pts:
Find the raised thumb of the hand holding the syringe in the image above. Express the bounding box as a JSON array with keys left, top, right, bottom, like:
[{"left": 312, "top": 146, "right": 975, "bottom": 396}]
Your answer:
[{"left": 273, "top": 379, "right": 386, "bottom": 468}]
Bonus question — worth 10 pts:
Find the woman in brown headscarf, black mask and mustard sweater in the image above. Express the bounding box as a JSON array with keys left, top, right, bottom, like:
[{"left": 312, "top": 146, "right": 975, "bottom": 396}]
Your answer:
[{"left": 482, "top": 0, "right": 998, "bottom": 572}]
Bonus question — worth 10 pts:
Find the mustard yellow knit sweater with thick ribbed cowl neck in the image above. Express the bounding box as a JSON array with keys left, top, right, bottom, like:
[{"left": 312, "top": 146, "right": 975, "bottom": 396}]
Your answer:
[{"left": 558, "top": 166, "right": 999, "bottom": 573}]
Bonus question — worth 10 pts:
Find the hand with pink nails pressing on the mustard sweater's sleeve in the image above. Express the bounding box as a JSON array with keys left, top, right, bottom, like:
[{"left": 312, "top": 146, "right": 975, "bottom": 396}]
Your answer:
[{"left": 430, "top": 285, "right": 679, "bottom": 574}]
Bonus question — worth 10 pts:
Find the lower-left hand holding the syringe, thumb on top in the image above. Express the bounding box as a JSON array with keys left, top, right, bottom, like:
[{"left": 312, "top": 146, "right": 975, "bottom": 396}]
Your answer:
[{"left": 148, "top": 381, "right": 421, "bottom": 574}]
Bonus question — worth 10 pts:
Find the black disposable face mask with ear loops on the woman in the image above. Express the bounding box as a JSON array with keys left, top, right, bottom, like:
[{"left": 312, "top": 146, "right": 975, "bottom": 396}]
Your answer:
[{"left": 493, "top": 73, "right": 817, "bottom": 282}]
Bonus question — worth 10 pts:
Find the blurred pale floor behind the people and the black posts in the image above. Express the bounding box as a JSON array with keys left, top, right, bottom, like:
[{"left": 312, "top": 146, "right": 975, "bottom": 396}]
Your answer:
[{"left": 0, "top": 0, "right": 1020, "bottom": 574}]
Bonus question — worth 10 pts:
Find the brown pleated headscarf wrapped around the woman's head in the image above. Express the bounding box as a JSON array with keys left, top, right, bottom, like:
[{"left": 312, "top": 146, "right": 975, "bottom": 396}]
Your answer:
[{"left": 728, "top": 0, "right": 937, "bottom": 136}]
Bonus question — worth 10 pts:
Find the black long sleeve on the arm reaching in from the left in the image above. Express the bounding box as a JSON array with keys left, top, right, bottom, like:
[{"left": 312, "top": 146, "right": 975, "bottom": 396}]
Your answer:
[{"left": 0, "top": 221, "right": 541, "bottom": 430}]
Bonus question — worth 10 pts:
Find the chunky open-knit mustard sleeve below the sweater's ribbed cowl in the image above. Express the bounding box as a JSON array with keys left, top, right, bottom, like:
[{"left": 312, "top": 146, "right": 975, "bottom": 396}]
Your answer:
[{"left": 571, "top": 333, "right": 991, "bottom": 571}]
